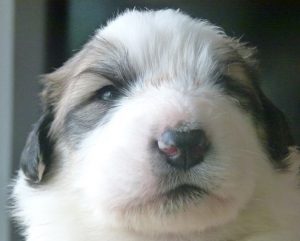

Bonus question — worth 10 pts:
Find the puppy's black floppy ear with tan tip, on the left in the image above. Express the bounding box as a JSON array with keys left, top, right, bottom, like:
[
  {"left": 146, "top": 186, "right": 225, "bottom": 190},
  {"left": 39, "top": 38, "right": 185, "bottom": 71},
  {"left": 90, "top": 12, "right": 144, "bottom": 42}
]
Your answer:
[{"left": 21, "top": 112, "right": 54, "bottom": 183}]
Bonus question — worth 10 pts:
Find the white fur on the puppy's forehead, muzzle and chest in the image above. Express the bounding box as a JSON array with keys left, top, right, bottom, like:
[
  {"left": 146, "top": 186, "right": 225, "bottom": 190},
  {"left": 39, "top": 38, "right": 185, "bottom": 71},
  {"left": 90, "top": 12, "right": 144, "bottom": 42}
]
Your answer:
[{"left": 13, "top": 10, "right": 300, "bottom": 241}]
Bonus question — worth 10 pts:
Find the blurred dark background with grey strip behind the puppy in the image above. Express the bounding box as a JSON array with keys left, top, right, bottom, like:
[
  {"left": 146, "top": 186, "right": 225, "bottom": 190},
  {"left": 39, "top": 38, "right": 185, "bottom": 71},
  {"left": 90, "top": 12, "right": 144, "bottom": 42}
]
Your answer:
[{"left": 0, "top": 0, "right": 300, "bottom": 241}]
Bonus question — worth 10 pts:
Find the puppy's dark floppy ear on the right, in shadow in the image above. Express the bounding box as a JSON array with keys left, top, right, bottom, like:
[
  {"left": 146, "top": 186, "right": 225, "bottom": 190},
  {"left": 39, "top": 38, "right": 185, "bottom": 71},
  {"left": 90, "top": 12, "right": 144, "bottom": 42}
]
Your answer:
[{"left": 259, "top": 90, "right": 295, "bottom": 168}]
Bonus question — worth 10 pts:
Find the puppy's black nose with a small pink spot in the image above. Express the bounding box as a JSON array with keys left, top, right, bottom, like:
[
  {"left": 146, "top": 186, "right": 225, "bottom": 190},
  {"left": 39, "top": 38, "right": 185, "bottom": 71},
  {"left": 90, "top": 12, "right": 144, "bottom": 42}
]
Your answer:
[{"left": 158, "top": 129, "right": 208, "bottom": 170}]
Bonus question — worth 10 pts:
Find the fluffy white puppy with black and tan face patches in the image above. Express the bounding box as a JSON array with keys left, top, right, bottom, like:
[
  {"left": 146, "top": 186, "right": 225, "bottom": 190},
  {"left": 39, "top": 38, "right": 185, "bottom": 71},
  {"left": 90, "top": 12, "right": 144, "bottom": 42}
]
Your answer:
[{"left": 13, "top": 10, "right": 300, "bottom": 241}]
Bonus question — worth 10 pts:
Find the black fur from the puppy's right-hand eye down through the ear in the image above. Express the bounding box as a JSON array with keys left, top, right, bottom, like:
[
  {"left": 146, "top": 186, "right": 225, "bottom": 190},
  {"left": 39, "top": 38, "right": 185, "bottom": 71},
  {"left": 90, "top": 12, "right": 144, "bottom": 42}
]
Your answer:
[{"left": 218, "top": 76, "right": 295, "bottom": 169}]
